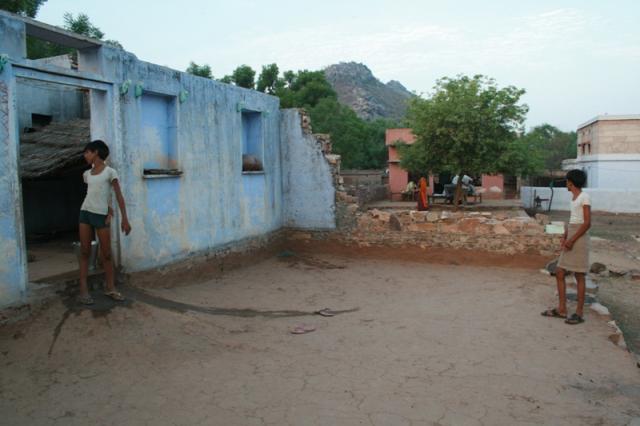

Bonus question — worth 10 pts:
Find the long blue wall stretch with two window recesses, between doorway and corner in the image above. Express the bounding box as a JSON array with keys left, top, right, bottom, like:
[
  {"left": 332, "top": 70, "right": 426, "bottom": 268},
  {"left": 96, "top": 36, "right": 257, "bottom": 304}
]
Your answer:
[{"left": 104, "top": 55, "right": 283, "bottom": 271}]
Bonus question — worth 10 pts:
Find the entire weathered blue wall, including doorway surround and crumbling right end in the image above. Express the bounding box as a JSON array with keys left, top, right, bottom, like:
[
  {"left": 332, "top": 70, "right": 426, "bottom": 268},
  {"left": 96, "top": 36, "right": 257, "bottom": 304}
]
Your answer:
[{"left": 0, "top": 13, "right": 335, "bottom": 305}]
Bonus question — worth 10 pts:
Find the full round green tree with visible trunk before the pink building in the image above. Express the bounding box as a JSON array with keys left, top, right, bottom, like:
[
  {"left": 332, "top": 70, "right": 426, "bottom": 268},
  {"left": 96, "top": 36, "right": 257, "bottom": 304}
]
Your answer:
[{"left": 400, "top": 75, "right": 528, "bottom": 206}]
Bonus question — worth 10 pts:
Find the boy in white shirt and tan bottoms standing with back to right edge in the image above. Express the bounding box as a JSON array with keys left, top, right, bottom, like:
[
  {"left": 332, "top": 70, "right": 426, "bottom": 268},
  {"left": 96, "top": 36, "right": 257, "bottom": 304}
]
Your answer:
[{"left": 542, "top": 170, "right": 591, "bottom": 325}]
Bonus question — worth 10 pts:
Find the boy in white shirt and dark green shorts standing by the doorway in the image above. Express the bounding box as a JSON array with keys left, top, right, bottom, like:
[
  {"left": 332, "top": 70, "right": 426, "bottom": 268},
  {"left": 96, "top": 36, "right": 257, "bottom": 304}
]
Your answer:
[{"left": 78, "top": 140, "right": 131, "bottom": 305}]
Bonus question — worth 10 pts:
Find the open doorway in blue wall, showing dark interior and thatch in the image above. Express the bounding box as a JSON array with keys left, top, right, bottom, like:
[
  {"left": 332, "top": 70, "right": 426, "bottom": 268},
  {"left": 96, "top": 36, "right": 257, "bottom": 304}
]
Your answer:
[{"left": 16, "top": 77, "right": 105, "bottom": 283}]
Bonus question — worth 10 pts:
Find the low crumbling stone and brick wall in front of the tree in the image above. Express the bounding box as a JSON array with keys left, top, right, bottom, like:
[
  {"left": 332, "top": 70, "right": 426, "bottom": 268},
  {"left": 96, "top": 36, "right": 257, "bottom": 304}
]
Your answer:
[{"left": 339, "top": 210, "right": 560, "bottom": 257}]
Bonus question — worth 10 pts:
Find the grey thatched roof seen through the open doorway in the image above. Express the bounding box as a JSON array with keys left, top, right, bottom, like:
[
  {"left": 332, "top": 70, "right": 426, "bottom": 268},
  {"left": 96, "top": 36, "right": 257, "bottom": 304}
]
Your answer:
[{"left": 20, "top": 119, "right": 91, "bottom": 179}]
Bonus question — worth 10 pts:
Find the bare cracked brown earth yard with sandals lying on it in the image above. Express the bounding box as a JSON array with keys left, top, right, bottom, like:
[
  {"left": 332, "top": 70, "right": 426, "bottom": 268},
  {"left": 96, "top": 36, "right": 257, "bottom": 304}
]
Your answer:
[{"left": 0, "top": 254, "right": 640, "bottom": 425}]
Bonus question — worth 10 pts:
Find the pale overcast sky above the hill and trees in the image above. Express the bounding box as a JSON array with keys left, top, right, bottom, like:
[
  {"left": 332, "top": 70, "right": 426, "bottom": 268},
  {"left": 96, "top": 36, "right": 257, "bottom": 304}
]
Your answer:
[{"left": 37, "top": 0, "right": 640, "bottom": 130}]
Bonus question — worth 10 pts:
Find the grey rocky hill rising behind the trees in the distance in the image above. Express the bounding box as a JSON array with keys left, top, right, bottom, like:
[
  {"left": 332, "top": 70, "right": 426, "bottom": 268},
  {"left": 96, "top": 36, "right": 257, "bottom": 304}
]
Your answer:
[{"left": 324, "top": 62, "right": 413, "bottom": 120}]
